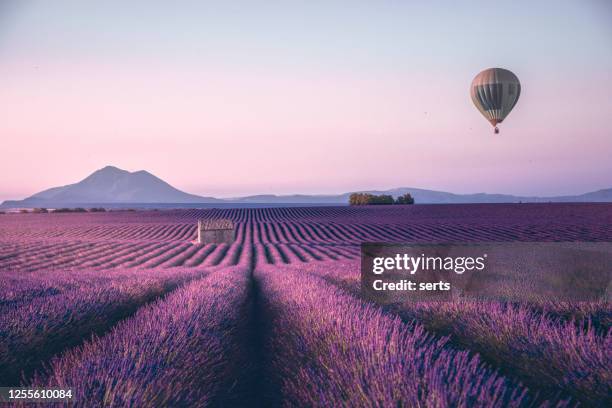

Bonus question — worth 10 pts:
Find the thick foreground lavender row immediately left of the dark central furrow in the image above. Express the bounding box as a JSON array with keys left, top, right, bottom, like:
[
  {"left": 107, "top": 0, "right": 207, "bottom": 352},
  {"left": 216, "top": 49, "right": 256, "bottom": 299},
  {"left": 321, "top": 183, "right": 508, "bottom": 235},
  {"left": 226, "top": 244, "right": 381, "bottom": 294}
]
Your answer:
[{"left": 33, "top": 268, "right": 249, "bottom": 407}]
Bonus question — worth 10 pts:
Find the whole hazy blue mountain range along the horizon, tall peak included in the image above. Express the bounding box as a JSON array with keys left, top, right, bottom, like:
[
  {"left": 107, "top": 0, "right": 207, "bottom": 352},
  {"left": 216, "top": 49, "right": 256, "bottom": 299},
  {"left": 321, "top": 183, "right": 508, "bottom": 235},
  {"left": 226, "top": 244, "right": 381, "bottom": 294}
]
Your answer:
[{"left": 0, "top": 166, "right": 612, "bottom": 208}]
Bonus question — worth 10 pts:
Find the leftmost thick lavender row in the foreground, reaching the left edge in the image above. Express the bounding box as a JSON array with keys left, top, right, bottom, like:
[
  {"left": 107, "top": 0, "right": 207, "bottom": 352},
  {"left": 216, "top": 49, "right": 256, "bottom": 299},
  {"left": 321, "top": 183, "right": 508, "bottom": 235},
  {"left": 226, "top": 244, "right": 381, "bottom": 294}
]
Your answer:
[{"left": 0, "top": 269, "right": 202, "bottom": 385}]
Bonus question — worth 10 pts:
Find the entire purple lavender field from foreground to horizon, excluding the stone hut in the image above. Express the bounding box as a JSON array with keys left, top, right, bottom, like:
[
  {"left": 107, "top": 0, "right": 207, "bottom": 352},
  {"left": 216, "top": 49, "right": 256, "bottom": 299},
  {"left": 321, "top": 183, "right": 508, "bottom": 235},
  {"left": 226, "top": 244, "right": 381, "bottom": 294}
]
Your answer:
[{"left": 0, "top": 204, "right": 612, "bottom": 407}]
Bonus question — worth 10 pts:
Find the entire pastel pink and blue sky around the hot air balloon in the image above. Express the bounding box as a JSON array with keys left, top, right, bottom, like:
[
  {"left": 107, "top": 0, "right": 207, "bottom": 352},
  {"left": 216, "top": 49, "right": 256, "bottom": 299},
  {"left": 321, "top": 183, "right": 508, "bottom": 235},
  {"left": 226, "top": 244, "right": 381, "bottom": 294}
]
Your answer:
[{"left": 0, "top": 0, "right": 612, "bottom": 200}]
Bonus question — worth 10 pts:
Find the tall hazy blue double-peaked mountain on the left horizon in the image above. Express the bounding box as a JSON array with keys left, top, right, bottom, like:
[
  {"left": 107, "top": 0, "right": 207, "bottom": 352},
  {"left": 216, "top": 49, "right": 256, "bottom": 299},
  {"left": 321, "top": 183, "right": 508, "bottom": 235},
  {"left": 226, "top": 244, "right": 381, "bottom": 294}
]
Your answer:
[{"left": 2, "top": 166, "right": 222, "bottom": 207}]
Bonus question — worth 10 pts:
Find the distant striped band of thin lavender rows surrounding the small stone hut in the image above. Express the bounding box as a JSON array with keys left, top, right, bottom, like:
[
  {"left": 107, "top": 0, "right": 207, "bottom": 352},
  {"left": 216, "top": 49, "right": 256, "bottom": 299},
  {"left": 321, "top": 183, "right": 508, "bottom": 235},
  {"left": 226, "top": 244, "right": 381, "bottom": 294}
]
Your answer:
[{"left": 0, "top": 204, "right": 612, "bottom": 271}]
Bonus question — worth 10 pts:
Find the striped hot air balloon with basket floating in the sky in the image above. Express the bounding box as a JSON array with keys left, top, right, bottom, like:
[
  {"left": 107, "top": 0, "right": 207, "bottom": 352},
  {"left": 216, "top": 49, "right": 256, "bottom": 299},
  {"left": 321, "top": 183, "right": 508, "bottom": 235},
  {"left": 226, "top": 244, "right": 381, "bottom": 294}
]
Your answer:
[{"left": 470, "top": 68, "right": 521, "bottom": 134}]
